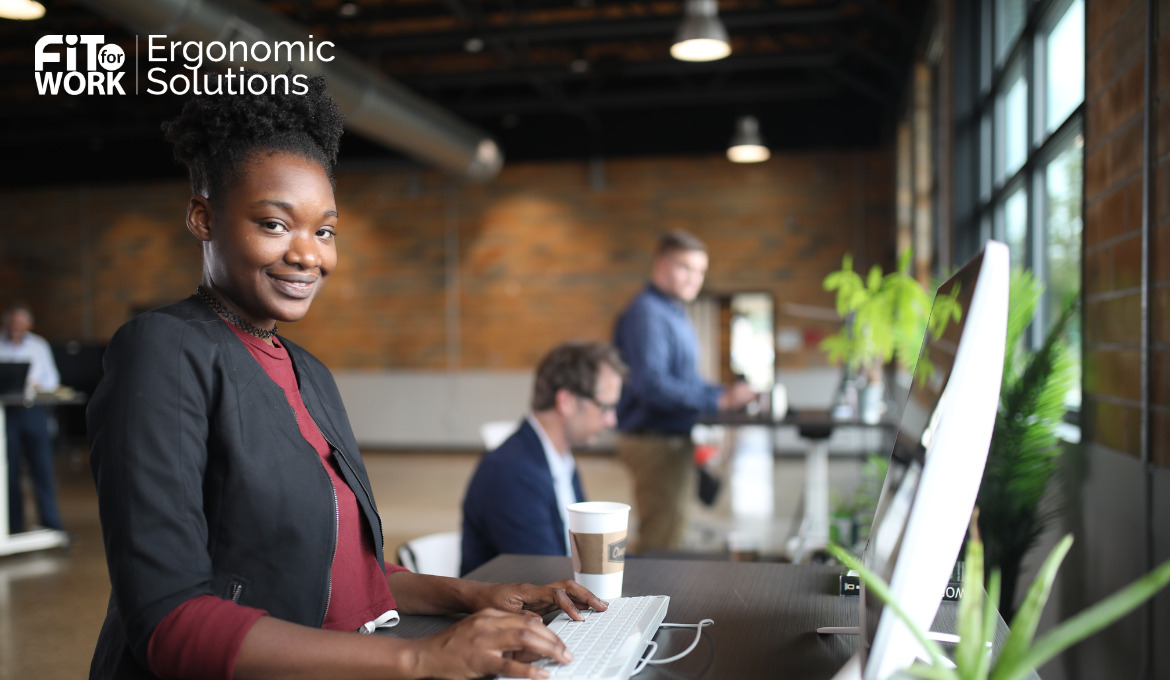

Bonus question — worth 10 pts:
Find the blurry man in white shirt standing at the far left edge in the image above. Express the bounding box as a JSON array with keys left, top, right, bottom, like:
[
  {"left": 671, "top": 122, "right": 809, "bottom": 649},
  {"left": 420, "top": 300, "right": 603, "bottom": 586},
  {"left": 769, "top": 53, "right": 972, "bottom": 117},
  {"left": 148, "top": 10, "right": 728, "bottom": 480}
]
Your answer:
[{"left": 0, "top": 303, "right": 64, "bottom": 534}]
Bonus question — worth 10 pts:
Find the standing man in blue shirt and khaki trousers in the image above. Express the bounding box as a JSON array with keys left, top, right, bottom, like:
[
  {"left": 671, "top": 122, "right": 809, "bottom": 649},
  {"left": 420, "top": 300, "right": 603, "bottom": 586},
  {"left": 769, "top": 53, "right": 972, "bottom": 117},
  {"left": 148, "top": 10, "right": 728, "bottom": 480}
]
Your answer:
[{"left": 613, "top": 231, "right": 756, "bottom": 554}]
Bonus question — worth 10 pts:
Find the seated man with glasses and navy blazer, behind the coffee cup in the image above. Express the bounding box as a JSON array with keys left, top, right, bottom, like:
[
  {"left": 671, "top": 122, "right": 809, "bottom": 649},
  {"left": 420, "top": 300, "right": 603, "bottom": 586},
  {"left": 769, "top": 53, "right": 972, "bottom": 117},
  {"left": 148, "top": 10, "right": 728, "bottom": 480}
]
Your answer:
[{"left": 460, "top": 343, "right": 626, "bottom": 573}]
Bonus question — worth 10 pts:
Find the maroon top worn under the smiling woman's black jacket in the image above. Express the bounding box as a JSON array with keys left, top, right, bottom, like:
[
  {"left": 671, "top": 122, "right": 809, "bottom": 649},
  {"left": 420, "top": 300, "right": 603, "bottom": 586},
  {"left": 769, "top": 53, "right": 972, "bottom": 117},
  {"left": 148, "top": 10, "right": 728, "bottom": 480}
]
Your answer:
[{"left": 147, "top": 322, "right": 404, "bottom": 680}]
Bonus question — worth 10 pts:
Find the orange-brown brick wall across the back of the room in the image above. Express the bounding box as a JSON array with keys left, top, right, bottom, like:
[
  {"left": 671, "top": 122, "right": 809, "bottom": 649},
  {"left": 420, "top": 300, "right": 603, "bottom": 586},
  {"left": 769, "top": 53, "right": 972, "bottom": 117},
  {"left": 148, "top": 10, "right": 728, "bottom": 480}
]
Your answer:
[{"left": 0, "top": 151, "right": 893, "bottom": 369}]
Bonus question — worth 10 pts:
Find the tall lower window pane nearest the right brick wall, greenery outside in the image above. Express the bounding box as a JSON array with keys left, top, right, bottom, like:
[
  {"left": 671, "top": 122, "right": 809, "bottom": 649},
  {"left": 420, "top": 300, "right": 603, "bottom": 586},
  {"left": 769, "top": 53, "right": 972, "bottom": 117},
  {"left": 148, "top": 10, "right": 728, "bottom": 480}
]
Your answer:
[{"left": 1044, "top": 135, "right": 1085, "bottom": 406}]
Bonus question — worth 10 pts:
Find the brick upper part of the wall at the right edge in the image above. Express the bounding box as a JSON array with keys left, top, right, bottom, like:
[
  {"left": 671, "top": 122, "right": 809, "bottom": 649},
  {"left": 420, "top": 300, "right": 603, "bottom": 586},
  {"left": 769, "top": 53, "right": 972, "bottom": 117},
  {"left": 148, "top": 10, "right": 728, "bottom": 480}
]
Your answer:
[{"left": 1083, "top": 0, "right": 1170, "bottom": 466}]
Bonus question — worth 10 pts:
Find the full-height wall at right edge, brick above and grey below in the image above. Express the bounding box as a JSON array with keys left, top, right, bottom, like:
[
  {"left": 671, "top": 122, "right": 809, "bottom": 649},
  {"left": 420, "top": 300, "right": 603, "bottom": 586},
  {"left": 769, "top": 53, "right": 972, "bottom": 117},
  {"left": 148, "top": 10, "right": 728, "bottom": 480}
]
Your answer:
[{"left": 1060, "top": 0, "right": 1170, "bottom": 680}]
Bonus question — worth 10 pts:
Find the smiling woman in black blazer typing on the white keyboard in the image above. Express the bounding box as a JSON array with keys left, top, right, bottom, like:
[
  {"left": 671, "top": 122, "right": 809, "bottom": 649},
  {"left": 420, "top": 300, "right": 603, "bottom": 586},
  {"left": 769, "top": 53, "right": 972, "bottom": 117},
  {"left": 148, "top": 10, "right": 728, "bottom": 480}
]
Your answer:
[{"left": 87, "top": 72, "right": 606, "bottom": 680}]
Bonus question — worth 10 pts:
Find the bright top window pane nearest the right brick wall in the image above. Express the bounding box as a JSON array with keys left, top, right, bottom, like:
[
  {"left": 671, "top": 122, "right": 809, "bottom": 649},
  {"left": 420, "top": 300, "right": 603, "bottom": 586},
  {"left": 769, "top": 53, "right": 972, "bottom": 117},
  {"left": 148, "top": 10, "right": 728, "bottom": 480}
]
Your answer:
[{"left": 1045, "top": 0, "right": 1085, "bottom": 132}]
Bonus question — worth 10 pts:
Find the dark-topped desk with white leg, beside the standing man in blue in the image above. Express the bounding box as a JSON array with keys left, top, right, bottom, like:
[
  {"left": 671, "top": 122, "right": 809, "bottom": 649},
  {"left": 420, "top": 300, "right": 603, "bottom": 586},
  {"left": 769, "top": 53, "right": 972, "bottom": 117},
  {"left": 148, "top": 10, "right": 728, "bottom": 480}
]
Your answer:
[{"left": 701, "top": 410, "right": 897, "bottom": 562}]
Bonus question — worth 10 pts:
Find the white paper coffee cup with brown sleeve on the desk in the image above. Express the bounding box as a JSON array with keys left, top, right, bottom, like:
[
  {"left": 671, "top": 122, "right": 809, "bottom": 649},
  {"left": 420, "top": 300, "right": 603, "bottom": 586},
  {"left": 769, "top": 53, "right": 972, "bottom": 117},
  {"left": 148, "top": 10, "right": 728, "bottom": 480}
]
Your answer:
[{"left": 569, "top": 501, "right": 629, "bottom": 600}]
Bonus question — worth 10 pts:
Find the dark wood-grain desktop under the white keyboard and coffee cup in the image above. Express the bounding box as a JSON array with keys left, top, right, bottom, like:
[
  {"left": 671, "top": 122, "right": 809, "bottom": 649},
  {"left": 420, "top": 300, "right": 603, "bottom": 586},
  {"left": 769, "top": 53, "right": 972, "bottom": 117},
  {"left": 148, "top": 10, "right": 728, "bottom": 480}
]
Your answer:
[{"left": 386, "top": 555, "right": 1007, "bottom": 680}]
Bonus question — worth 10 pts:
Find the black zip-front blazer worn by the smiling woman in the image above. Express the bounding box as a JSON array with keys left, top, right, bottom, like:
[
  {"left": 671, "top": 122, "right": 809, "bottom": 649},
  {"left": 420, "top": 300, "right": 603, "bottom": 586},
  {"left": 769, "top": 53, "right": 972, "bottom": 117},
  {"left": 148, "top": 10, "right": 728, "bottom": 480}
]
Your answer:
[{"left": 87, "top": 296, "right": 383, "bottom": 679}]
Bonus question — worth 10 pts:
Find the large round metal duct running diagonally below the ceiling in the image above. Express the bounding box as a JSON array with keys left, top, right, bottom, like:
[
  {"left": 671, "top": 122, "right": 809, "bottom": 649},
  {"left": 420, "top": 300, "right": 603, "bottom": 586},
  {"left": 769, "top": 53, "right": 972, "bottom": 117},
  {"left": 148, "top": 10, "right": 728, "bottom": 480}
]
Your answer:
[{"left": 73, "top": 0, "right": 503, "bottom": 181}]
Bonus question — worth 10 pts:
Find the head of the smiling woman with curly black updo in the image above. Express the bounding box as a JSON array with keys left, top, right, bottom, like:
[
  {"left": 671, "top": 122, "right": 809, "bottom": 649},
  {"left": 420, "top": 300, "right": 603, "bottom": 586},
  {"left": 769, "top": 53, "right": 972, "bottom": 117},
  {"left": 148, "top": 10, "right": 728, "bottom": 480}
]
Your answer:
[{"left": 164, "top": 69, "right": 342, "bottom": 342}]
